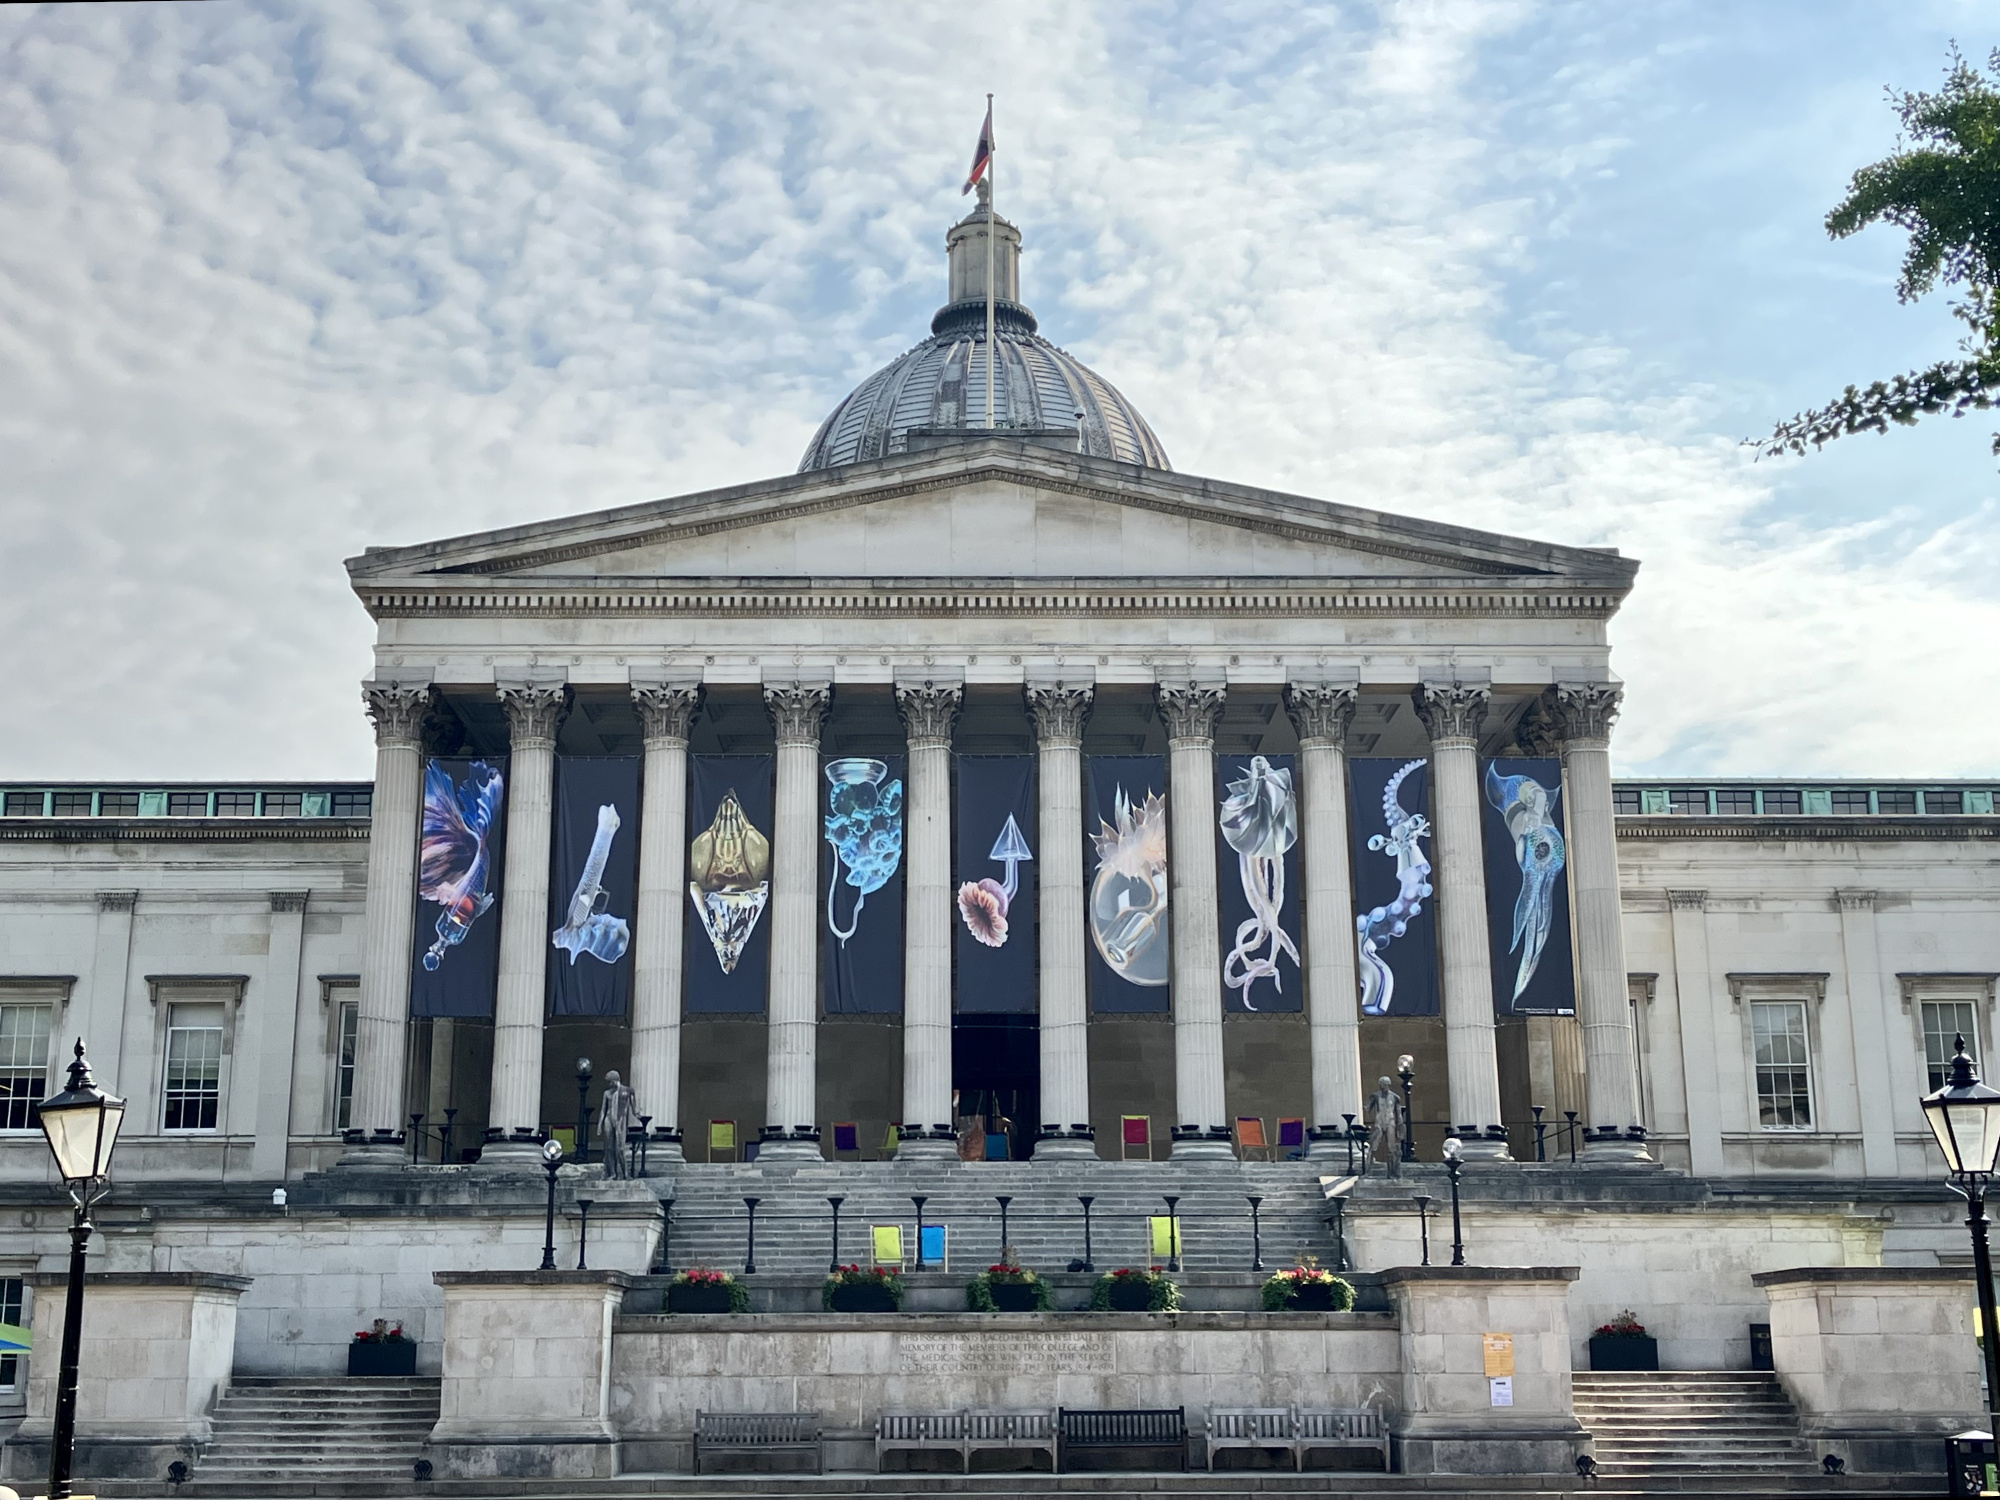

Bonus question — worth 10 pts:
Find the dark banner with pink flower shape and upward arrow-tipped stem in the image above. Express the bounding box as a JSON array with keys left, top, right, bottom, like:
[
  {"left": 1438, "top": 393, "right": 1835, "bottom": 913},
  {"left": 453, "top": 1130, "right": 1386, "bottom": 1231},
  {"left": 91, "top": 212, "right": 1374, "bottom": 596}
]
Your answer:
[{"left": 954, "top": 756, "right": 1040, "bottom": 1016}]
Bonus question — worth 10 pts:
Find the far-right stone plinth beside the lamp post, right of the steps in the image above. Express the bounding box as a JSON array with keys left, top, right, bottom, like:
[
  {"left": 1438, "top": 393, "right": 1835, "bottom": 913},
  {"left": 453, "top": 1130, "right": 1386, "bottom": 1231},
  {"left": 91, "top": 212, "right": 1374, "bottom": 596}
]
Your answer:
[{"left": 1750, "top": 1266, "right": 1986, "bottom": 1474}]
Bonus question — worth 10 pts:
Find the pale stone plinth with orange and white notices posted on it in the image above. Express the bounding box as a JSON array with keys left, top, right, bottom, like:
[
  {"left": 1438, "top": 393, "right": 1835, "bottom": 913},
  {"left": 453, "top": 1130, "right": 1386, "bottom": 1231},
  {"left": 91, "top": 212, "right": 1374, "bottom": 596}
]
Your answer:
[{"left": 1382, "top": 1266, "right": 1588, "bottom": 1474}]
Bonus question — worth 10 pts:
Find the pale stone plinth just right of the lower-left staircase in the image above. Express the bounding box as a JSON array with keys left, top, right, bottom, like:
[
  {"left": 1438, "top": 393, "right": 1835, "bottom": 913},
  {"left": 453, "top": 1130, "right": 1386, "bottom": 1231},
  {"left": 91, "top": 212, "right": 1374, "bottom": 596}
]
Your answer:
[{"left": 426, "top": 1270, "right": 630, "bottom": 1480}]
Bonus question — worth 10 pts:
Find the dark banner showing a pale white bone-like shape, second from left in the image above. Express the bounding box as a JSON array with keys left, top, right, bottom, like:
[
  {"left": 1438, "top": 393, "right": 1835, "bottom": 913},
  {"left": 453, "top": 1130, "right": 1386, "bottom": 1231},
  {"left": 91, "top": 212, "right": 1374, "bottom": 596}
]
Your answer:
[{"left": 546, "top": 756, "right": 638, "bottom": 1016}]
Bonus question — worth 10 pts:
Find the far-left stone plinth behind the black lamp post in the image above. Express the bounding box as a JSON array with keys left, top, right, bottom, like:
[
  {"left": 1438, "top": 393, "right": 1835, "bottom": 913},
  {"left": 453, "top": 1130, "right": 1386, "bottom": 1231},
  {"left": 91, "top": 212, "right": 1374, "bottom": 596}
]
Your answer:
[{"left": 8, "top": 1270, "right": 250, "bottom": 1480}]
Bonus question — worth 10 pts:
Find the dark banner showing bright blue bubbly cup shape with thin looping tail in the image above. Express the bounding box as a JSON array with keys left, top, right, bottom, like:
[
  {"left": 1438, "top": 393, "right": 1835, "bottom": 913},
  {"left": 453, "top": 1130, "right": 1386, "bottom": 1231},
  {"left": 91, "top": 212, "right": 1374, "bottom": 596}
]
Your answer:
[{"left": 820, "top": 756, "right": 908, "bottom": 1016}]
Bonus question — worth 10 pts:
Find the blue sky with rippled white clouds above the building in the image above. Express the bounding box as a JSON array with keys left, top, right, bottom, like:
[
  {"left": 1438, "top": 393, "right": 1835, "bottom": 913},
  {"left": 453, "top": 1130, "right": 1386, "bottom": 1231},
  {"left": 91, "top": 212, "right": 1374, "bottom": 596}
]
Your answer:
[{"left": 0, "top": 0, "right": 2000, "bottom": 780}]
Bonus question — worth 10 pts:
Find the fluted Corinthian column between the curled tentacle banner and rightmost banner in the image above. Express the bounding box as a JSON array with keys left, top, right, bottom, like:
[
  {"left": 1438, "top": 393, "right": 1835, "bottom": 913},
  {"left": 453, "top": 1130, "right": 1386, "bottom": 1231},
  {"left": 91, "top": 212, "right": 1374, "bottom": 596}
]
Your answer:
[{"left": 1412, "top": 682, "right": 1508, "bottom": 1160}]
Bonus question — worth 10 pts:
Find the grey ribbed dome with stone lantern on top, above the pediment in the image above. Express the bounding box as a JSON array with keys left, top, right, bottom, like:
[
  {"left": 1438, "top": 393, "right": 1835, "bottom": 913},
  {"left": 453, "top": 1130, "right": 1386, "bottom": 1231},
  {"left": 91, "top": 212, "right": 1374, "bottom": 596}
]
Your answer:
[{"left": 798, "top": 194, "right": 1172, "bottom": 474}]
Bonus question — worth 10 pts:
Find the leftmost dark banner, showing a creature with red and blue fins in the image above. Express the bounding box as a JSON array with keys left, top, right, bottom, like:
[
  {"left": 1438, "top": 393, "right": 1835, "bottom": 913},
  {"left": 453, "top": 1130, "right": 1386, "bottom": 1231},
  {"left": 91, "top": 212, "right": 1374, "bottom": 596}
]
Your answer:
[{"left": 410, "top": 756, "right": 506, "bottom": 1020}]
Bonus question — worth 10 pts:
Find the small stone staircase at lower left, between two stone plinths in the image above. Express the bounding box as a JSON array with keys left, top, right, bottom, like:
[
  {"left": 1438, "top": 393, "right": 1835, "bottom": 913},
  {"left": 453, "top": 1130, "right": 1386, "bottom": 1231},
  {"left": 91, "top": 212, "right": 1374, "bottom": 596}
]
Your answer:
[{"left": 194, "top": 1376, "right": 438, "bottom": 1492}]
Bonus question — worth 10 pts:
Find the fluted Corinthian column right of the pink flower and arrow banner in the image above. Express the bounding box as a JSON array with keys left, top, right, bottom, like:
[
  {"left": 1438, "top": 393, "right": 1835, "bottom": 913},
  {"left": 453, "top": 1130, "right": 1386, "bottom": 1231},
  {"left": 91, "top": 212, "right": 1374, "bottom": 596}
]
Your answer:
[{"left": 1028, "top": 682, "right": 1098, "bottom": 1162}]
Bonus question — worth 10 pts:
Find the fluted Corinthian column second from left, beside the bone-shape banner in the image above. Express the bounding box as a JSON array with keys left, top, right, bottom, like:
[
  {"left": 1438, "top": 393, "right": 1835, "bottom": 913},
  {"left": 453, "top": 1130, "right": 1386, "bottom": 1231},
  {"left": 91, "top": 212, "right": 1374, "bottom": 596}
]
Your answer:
[{"left": 480, "top": 684, "right": 570, "bottom": 1170}]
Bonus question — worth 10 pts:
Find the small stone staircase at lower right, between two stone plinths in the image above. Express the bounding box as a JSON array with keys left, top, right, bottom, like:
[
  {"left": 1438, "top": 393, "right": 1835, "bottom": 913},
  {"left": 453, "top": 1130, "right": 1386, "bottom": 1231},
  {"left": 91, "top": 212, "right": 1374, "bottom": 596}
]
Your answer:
[{"left": 1574, "top": 1370, "right": 1820, "bottom": 1484}]
